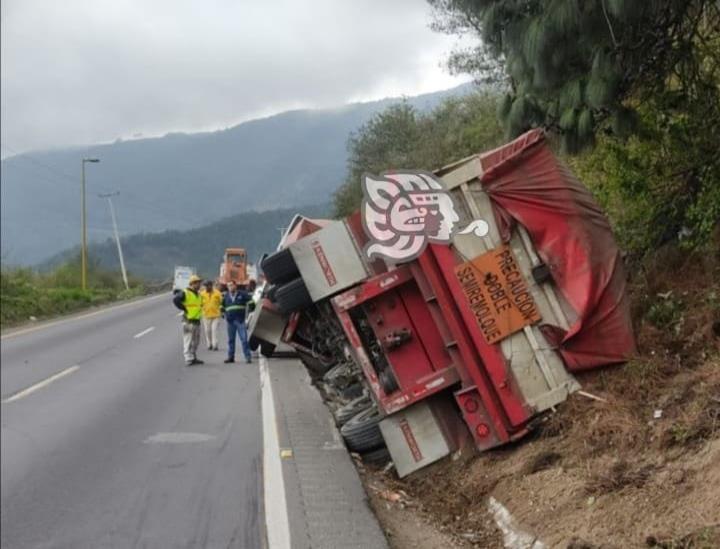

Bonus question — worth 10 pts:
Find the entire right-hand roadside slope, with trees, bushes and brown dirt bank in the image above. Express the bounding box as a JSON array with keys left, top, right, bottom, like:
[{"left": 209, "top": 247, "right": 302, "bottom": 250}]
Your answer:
[{"left": 342, "top": 0, "right": 720, "bottom": 549}]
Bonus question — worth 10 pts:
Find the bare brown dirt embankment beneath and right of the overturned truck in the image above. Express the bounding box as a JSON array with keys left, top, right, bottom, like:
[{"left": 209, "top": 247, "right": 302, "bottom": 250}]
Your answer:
[{"left": 367, "top": 246, "right": 720, "bottom": 549}]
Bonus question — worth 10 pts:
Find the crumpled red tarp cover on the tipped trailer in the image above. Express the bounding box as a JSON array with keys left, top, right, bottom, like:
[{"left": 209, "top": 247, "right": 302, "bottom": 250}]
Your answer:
[{"left": 480, "top": 130, "right": 635, "bottom": 371}]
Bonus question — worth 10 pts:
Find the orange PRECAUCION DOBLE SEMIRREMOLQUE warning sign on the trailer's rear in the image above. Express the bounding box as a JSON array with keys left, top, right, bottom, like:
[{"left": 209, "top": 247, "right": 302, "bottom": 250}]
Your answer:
[{"left": 455, "top": 245, "right": 542, "bottom": 343}]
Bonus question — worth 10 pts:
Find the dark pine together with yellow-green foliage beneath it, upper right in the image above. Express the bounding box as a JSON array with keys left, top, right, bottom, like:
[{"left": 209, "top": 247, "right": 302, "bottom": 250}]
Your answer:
[{"left": 428, "top": 0, "right": 720, "bottom": 255}]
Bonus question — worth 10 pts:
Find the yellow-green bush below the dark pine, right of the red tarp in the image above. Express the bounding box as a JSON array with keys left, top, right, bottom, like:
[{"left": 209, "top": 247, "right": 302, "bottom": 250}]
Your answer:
[{"left": 567, "top": 102, "right": 720, "bottom": 257}]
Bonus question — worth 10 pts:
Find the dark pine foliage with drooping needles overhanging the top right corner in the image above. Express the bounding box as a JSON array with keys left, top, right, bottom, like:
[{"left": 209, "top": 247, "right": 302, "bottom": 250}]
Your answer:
[{"left": 428, "top": 0, "right": 720, "bottom": 152}]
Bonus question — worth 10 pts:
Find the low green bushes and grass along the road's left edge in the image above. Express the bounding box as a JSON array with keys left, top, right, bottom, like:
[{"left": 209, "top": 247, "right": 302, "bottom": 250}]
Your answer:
[{"left": 0, "top": 257, "right": 145, "bottom": 328}]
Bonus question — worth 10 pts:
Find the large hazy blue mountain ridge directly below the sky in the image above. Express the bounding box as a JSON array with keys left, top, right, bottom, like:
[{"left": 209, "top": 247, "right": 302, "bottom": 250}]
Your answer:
[{"left": 0, "top": 84, "right": 473, "bottom": 265}]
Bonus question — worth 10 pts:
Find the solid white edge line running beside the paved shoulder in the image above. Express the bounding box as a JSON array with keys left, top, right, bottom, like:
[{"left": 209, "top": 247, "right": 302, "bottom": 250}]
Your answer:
[{"left": 260, "top": 356, "right": 290, "bottom": 549}]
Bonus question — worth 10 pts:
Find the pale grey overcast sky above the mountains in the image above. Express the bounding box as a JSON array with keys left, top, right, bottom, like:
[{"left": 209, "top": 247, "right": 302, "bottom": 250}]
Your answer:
[{"left": 1, "top": 0, "right": 467, "bottom": 157}]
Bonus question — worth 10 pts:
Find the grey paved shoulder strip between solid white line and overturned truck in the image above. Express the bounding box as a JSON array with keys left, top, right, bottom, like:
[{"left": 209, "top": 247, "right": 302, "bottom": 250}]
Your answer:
[{"left": 270, "top": 358, "right": 388, "bottom": 549}]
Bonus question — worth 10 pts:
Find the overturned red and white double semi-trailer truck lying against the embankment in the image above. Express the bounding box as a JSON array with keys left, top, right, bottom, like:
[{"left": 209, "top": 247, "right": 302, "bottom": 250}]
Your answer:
[{"left": 250, "top": 130, "right": 635, "bottom": 476}]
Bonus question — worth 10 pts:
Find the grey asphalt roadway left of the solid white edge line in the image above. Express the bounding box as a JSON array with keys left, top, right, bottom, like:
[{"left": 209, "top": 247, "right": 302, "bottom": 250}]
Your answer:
[{"left": 0, "top": 294, "right": 264, "bottom": 549}]
